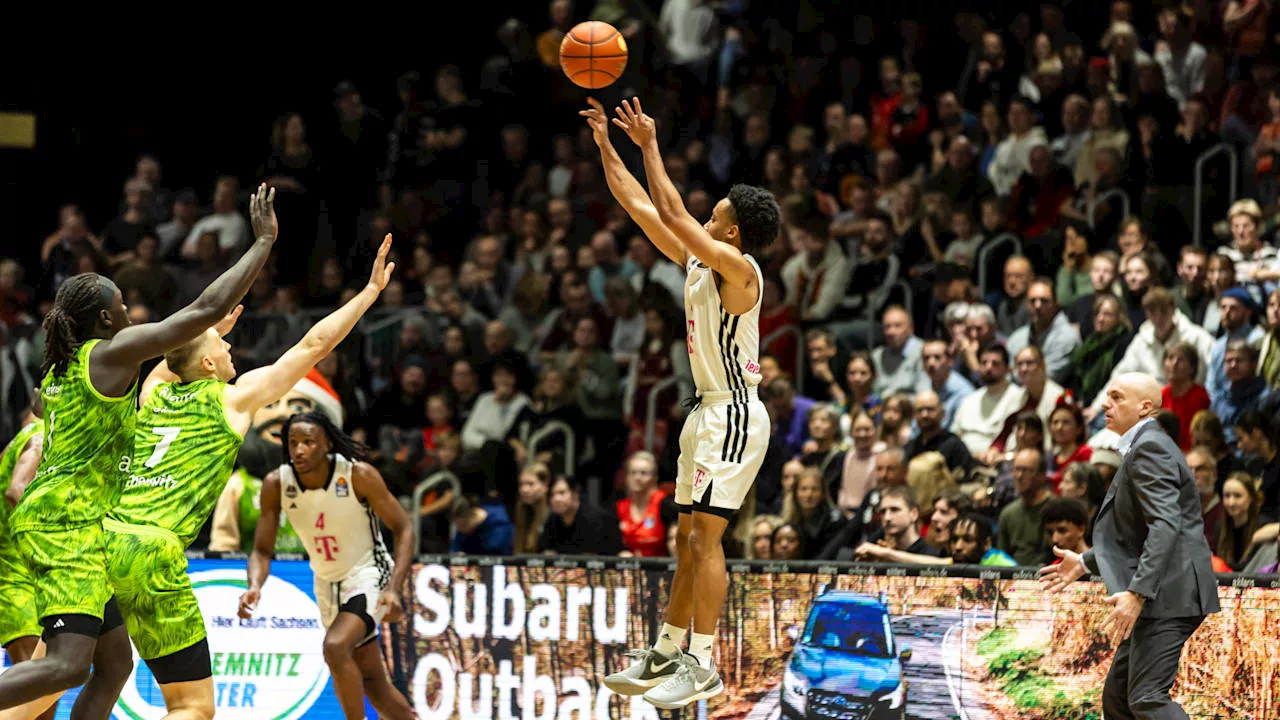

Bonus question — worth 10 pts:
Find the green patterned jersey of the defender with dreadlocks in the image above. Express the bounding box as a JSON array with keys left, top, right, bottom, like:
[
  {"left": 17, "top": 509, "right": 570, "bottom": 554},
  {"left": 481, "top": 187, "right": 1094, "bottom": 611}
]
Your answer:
[{"left": 9, "top": 340, "right": 138, "bottom": 532}]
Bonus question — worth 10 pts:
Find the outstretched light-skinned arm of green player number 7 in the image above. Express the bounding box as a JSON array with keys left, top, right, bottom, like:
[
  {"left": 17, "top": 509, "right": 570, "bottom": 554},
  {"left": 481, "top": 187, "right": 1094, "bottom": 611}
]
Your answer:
[{"left": 225, "top": 234, "right": 396, "bottom": 430}]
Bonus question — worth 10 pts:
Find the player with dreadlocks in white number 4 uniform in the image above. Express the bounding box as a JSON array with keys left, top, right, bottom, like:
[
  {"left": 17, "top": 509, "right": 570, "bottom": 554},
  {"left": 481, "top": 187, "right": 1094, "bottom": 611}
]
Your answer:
[{"left": 239, "top": 413, "right": 413, "bottom": 720}]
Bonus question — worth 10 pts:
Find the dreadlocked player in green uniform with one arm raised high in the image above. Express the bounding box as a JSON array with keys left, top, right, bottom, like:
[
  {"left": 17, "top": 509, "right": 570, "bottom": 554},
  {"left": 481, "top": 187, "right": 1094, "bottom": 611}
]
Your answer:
[{"left": 0, "top": 186, "right": 276, "bottom": 717}]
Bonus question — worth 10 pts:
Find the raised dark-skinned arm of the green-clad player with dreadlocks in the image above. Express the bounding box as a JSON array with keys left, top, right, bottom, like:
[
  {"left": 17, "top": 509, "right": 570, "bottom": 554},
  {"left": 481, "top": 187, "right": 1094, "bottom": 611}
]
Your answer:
[{"left": 92, "top": 186, "right": 278, "bottom": 384}]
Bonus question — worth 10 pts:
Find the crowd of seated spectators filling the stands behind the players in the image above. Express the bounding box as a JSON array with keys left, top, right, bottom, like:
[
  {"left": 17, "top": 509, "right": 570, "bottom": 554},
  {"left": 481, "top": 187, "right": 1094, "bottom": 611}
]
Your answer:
[{"left": 0, "top": 0, "right": 1280, "bottom": 573}]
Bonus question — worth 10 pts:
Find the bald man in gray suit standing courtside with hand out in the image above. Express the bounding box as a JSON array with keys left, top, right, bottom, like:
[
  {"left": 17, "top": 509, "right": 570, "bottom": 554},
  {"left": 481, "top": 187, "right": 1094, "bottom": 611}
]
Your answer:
[{"left": 1041, "top": 373, "right": 1219, "bottom": 720}]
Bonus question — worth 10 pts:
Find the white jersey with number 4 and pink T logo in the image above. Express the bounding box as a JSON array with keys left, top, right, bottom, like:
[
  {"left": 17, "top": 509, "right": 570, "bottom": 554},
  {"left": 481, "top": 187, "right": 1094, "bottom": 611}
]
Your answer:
[{"left": 280, "top": 454, "right": 392, "bottom": 584}]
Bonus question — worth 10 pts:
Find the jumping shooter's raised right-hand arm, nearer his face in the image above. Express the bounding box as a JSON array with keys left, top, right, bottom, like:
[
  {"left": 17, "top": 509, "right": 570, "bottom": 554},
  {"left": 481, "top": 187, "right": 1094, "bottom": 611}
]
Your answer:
[{"left": 613, "top": 99, "right": 755, "bottom": 287}]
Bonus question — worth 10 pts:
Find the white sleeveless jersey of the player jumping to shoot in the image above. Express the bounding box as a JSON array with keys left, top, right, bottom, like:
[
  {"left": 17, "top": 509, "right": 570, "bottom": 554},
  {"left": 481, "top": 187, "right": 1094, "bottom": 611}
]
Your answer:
[{"left": 685, "top": 255, "right": 764, "bottom": 401}]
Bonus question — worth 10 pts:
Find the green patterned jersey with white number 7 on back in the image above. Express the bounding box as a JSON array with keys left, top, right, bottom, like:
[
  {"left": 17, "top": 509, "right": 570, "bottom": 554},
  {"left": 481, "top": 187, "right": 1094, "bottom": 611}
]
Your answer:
[{"left": 108, "top": 379, "right": 244, "bottom": 547}]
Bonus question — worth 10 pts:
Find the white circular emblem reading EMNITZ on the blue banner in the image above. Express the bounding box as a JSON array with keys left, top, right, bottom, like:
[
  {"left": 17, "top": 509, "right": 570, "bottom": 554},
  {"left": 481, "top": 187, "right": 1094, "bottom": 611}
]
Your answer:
[{"left": 115, "top": 564, "right": 329, "bottom": 720}]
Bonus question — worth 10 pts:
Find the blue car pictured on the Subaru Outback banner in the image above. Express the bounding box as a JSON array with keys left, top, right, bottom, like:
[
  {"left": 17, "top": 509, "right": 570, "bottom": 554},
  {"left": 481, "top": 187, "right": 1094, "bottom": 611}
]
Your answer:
[{"left": 781, "top": 591, "right": 911, "bottom": 720}]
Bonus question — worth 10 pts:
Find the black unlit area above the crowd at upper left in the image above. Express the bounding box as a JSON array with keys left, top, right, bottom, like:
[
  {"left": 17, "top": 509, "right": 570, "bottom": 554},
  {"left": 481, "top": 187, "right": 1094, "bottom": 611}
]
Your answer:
[{"left": 0, "top": 7, "right": 560, "bottom": 266}]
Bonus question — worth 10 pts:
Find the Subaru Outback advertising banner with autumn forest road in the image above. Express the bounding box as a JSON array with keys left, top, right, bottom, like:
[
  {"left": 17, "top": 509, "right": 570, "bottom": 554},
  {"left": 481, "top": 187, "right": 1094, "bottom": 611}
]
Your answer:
[{"left": 394, "top": 557, "right": 1280, "bottom": 720}]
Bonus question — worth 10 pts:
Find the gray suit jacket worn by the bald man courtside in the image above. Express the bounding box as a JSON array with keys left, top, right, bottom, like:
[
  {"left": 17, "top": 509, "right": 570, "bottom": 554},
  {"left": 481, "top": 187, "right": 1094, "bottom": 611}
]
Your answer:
[{"left": 1084, "top": 423, "right": 1219, "bottom": 618}]
